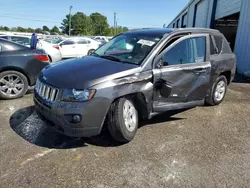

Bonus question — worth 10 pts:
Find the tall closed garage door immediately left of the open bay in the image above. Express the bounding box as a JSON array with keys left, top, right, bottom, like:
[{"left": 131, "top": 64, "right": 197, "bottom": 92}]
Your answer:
[{"left": 194, "top": 0, "right": 208, "bottom": 27}]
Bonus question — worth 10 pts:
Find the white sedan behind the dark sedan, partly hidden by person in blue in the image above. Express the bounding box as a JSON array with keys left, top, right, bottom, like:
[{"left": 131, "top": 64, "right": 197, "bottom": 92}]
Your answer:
[{"left": 0, "top": 35, "right": 62, "bottom": 62}]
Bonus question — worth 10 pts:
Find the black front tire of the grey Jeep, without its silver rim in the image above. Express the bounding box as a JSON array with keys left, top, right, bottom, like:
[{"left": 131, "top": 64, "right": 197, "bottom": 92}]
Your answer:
[{"left": 108, "top": 98, "right": 139, "bottom": 143}]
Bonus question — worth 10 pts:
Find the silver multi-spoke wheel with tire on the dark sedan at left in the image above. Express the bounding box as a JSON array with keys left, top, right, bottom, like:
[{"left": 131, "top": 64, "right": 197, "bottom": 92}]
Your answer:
[{"left": 0, "top": 71, "right": 29, "bottom": 99}]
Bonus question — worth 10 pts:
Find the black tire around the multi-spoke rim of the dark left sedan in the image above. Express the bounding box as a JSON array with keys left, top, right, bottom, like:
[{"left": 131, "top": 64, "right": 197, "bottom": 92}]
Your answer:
[{"left": 0, "top": 71, "right": 29, "bottom": 99}]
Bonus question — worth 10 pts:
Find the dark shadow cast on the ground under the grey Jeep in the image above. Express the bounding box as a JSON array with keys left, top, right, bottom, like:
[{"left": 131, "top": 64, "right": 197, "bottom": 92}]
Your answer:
[{"left": 9, "top": 106, "right": 185, "bottom": 149}]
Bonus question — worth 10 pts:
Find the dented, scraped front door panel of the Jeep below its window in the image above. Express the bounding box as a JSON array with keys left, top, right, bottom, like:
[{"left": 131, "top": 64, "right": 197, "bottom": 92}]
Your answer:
[{"left": 154, "top": 62, "right": 211, "bottom": 103}]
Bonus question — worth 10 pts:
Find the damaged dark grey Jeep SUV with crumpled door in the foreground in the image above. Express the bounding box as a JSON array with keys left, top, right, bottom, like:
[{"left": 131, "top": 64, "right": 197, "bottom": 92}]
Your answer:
[{"left": 34, "top": 28, "right": 236, "bottom": 143}]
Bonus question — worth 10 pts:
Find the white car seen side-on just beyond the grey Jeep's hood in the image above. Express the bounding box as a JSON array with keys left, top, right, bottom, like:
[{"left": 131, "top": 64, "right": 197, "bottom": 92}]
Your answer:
[{"left": 58, "top": 37, "right": 100, "bottom": 58}]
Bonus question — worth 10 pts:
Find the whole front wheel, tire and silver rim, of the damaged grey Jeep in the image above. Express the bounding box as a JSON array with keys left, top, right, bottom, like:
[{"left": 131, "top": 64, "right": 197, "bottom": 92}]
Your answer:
[{"left": 108, "top": 98, "right": 139, "bottom": 143}]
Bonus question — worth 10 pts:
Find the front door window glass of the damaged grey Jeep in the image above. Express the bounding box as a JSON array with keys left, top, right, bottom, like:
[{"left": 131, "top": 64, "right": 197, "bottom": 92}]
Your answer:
[{"left": 163, "top": 37, "right": 206, "bottom": 66}]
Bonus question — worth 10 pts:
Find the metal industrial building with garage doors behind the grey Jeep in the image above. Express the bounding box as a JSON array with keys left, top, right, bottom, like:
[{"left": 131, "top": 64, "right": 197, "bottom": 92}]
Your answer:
[{"left": 167, "top": 0, "right": 250, "bottom": 76}]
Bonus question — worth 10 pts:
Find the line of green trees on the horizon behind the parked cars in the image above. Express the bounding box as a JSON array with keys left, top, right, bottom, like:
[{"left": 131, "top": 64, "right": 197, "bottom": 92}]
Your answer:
[{"left": 0, "top": 12, "right": 128, "bottom": 36}]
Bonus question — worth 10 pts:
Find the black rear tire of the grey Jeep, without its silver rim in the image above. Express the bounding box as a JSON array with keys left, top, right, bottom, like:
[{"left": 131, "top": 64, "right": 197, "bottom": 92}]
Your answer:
[{"left": 205, "top": 75, "right": 227, "bottom": 106}]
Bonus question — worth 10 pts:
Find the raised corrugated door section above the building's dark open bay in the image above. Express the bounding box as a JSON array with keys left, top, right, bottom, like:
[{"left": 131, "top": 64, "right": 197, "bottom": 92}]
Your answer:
[{"left": 215, "top": 0, "right": 241, "bottom": 19}]
